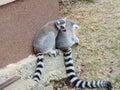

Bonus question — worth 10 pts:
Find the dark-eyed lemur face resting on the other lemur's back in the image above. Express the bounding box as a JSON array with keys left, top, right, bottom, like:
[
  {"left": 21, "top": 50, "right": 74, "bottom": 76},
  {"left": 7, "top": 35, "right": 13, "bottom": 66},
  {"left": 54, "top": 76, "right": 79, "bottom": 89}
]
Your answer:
[{"left": 55, "top": 18, "right": 67, "bottom": 32}]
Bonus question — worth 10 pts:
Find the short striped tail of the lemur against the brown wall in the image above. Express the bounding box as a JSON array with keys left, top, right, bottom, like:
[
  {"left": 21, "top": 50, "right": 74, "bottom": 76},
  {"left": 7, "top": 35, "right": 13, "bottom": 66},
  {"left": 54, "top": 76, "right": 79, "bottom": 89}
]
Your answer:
[{"left": 33, "top": 53, "right": 44, "bottom": 82}]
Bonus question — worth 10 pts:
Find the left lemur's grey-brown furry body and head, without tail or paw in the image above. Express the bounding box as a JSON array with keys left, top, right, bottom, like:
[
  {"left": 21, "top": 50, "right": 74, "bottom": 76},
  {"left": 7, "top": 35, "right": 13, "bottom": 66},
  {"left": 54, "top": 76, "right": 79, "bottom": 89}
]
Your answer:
[{"left": 33, "top": 18, "right": 66, "bottom": 54}]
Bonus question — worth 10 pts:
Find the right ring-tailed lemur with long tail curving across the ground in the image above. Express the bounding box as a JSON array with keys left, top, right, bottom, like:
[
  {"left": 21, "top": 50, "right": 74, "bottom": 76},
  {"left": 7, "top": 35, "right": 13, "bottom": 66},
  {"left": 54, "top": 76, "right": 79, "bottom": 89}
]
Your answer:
[{"left": 56, "top": 19, "right": 112, "bottom": 90}]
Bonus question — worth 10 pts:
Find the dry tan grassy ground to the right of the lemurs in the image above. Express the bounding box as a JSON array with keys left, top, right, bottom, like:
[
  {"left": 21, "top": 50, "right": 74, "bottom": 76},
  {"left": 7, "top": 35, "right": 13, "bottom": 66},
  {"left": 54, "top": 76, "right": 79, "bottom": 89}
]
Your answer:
[{"left": 51, "top": 0, "right": 120, "bottom": 90}]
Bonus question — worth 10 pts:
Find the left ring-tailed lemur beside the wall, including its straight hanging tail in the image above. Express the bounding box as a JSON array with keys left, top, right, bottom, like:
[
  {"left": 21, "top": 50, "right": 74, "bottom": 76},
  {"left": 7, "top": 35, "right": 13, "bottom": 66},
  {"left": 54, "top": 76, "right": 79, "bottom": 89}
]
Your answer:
[{"left": 33, "top": 18, "right": 66, "bottom": 82}]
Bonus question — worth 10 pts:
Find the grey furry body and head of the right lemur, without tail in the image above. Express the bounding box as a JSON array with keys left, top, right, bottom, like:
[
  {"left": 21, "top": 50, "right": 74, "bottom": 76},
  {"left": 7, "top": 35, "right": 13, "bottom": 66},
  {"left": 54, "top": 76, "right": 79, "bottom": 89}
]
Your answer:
[{"left": 56, "top": 19, "right": 79, "bottom": 50}]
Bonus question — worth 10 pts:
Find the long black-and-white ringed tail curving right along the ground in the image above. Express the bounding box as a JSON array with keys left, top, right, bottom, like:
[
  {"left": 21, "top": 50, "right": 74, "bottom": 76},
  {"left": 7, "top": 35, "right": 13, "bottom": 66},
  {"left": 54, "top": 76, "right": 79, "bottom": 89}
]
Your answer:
[{"left": 63, "top": 48, "right": 112, "bottom": 90}]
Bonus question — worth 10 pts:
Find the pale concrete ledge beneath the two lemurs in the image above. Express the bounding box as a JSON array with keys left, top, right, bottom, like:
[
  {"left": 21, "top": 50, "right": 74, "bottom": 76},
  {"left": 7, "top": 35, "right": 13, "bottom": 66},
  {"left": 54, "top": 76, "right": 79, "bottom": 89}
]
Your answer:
[{"left": 0, "top": 53, "right": 66, "bottom": 90}]
